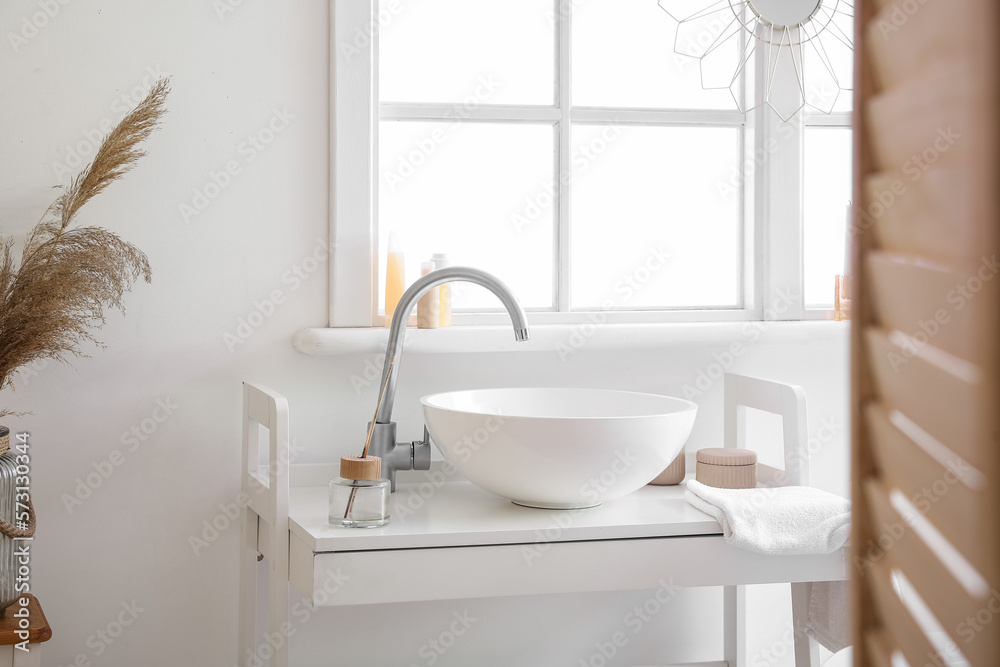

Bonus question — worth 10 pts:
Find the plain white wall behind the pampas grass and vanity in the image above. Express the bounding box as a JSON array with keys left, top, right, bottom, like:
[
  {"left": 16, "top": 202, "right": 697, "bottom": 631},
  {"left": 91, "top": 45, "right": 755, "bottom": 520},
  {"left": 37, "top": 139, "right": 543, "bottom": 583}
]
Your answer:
[{"left": 0, "top": 0, "right": 847, "bottom": 667}]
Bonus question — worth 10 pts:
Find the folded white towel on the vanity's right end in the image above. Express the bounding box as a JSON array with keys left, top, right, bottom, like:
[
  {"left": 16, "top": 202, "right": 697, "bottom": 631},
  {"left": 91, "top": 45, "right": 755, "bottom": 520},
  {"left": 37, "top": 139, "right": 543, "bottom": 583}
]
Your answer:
[{"left": 684, "top": 479, "right": 851, "bottom": 555}]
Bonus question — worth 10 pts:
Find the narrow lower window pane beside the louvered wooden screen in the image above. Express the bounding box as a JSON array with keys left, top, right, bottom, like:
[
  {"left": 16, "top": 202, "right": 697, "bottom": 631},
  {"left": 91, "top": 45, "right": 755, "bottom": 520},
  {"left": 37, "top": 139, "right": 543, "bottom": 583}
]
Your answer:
[{"left": 803, "top": 127, "right": 852, "bottom": 308}]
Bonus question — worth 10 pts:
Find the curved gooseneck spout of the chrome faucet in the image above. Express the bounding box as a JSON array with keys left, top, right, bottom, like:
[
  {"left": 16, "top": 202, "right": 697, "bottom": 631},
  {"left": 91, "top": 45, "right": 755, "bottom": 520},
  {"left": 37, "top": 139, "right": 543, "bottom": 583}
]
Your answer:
[{"left": 375, "top": 266, "right": 529, "bottom": 424}]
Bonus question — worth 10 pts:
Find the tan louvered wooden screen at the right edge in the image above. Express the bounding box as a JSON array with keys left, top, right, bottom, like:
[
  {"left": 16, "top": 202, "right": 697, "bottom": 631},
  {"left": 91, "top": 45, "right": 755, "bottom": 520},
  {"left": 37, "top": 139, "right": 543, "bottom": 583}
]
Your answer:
[{"left": 841, "top": 0, "right": 1000, "bottom": 667}]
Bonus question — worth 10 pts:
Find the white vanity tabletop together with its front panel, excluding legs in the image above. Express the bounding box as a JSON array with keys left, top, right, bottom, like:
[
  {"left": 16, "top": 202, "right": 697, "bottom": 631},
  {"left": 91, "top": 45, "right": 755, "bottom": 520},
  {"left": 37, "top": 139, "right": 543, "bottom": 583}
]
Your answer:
[{"left": 289, "top": 474, "right": 844, "bottom": 606}]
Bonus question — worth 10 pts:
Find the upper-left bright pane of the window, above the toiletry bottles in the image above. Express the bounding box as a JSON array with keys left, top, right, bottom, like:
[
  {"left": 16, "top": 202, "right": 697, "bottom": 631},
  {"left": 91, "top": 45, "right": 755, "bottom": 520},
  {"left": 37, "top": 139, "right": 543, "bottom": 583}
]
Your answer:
[{"left": 379, "top": 0, "right": 556, "bottom": 105}]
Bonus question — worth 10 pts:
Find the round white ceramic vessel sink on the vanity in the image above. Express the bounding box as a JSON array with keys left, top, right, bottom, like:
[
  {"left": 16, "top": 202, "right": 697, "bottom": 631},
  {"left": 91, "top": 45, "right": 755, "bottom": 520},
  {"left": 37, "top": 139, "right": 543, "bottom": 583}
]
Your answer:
[{"left": 420, "top": 389, "right": 698, "bottom": 509}]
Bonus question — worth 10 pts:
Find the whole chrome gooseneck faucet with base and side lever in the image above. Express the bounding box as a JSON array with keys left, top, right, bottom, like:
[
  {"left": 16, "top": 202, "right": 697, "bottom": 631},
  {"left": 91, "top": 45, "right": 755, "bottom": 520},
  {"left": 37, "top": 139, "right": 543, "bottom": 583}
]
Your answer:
[{"left": 368, "top": 266, "right": 528, "bottom": 491}]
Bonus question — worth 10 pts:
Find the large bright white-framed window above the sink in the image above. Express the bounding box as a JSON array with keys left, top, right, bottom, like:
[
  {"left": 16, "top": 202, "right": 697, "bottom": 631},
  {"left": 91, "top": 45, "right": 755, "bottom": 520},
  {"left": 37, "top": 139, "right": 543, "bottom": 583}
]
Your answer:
[{"left": 331, "top": 0, "right": 850, "bottom": 326}]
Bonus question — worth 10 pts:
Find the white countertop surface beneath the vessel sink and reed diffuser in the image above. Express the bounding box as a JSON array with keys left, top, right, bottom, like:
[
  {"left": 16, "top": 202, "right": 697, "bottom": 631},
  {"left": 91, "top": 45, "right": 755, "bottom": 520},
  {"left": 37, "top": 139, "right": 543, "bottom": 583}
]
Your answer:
[{"left": 288, "top": 482, "right": 722, "bottom": 552}]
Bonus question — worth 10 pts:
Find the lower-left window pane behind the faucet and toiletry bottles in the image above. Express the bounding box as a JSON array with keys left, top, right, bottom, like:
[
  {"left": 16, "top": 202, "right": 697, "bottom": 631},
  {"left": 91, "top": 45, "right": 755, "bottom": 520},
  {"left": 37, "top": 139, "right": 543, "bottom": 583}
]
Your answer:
[{"left": 378, "top": 121, "right": 555, "bottom": 310}]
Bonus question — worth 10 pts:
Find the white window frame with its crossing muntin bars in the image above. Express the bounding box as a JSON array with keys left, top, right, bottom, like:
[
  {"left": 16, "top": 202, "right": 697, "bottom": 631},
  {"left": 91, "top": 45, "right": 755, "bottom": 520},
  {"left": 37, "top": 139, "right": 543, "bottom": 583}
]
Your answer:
[{"left": 329, "top": 0, "right": 836, "bottom": 328}]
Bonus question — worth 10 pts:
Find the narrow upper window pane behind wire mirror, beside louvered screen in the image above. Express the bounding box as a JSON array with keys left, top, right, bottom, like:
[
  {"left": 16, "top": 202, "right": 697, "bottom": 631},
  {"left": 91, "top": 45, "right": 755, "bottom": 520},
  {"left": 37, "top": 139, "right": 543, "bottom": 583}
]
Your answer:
[{"left": 803, "top": 5, "right": 854, "bottom": 112}]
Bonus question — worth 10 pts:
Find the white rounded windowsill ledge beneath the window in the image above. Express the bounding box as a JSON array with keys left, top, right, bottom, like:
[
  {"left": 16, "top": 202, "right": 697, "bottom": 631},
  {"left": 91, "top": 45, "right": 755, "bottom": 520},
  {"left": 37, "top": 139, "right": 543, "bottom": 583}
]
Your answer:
[{"left": 292, "top": 320, "right": 850, "bottom": 356}]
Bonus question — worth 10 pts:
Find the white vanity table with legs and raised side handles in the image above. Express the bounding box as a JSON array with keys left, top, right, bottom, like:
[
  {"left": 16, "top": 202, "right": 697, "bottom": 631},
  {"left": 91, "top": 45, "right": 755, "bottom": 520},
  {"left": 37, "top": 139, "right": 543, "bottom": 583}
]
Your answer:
[{"left": 237, "top": 375, "right": 847, "bottom": 667}]
